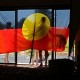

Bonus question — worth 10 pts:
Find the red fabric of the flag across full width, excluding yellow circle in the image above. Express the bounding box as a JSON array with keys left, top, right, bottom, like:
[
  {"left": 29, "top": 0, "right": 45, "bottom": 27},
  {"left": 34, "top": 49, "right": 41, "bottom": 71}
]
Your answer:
[{"left": 0, "top": 27, "right": 69, "bottom": 54}]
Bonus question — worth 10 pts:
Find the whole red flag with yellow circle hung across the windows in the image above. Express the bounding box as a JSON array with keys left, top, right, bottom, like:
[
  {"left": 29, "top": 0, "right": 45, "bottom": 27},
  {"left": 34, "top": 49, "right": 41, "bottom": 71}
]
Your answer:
[{"left": 0, "top": 13, "right": 69, "bottom": 54}]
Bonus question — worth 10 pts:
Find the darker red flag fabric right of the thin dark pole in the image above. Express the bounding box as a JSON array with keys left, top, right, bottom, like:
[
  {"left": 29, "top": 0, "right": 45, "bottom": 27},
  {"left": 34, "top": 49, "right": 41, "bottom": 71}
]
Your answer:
[{"left": 34, "top": 27, "right": 69, "bottom": 52}]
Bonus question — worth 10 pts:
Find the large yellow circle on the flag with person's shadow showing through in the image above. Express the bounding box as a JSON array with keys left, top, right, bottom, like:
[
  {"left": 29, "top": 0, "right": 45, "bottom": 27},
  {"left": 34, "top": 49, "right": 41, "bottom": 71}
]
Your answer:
[{"left": 22, "top": 13, "right": 50, "bottom": 40}]
